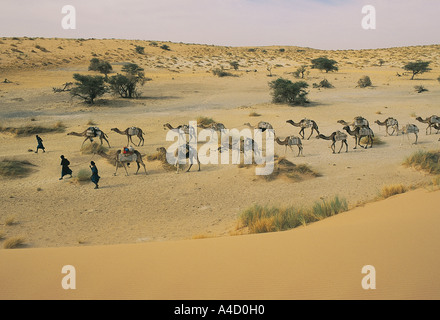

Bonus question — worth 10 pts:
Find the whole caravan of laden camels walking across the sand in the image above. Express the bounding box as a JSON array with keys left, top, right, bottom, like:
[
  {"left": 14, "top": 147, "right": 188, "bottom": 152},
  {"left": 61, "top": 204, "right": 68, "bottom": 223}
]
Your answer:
[{"left": 61, "top": 115, "right": 440, "bottom": 176}]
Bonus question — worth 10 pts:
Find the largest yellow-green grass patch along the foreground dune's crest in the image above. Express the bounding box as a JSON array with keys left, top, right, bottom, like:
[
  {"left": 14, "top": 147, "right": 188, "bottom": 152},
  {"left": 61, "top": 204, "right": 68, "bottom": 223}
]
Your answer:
[{"left": 238, "top": 196, "right": 348, "bottom": 233}]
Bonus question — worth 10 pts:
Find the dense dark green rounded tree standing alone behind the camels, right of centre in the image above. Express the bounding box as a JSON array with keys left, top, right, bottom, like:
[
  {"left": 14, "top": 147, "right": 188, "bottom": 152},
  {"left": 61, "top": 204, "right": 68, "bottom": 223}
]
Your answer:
[{"left": 269, "top": 78, "right": 309, "bottom": 105}]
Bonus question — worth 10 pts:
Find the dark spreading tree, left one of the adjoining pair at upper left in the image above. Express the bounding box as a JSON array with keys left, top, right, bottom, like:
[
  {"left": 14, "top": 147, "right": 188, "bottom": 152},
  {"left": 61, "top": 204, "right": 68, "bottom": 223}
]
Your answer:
[{"left": 70, "top": 73, "right": 106, "bottom": 104}]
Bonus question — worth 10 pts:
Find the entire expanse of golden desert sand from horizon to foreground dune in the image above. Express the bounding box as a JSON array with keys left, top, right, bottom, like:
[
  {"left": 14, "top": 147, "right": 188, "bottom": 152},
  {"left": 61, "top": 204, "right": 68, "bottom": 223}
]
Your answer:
[{"left": 0, "top": 38, "right": 440, "bottom": 299}]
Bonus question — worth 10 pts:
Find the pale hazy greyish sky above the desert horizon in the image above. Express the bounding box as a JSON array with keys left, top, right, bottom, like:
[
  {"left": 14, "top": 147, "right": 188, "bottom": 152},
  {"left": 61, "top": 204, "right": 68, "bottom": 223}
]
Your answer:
[{"left": 0, "top": 0, "right": 440, "bottom": 50}]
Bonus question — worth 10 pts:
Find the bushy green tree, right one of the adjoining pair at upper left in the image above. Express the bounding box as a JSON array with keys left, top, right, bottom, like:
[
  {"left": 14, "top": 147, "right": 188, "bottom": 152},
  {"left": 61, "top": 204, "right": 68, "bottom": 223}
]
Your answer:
[{"left": 108, "top": 63, "right": 146, "bottom": 99}]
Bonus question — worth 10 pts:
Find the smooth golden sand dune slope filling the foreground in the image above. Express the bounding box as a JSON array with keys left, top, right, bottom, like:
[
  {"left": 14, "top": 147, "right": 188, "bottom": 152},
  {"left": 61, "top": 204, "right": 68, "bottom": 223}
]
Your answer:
[{"left": 0, "top": 190, "right": 440, "bottom": 299}]
